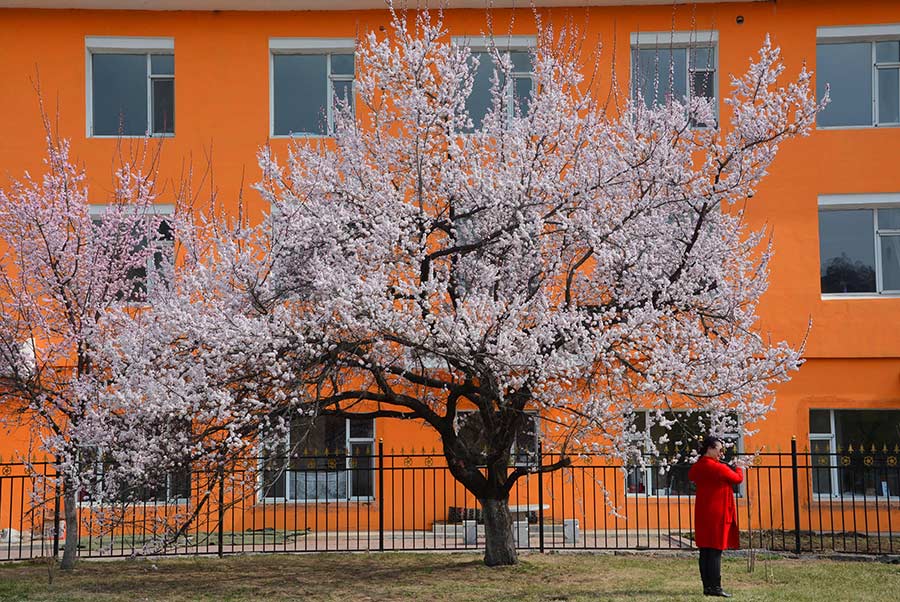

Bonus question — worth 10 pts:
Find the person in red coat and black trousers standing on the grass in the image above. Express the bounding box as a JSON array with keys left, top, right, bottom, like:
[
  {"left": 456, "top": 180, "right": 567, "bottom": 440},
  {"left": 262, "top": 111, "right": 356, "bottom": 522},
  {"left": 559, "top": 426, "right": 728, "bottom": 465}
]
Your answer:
[{"left": 688, "top": 437, "right": 744, "bottom": 598}]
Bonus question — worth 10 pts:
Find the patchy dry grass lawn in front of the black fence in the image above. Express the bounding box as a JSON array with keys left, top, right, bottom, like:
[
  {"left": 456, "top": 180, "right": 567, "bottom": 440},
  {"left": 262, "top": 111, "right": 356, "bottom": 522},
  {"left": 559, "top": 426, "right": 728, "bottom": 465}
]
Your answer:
[{"left": 0, "top": 553, "right": 900, "bottom": 602}]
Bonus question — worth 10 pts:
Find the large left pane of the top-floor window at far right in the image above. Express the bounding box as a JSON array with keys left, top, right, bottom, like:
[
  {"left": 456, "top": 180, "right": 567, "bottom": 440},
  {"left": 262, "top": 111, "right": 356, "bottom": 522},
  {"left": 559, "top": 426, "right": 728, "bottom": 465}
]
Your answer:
[{"left": 816, "top": 42, "right": 872, "bottom": 126}]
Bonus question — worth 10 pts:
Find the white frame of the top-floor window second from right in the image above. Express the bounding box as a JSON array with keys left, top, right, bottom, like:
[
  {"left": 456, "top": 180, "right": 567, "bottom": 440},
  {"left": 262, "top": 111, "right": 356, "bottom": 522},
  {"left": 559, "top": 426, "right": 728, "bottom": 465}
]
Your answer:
[{"left": 628, "top": 29, "right": 720, "bottom": 123}]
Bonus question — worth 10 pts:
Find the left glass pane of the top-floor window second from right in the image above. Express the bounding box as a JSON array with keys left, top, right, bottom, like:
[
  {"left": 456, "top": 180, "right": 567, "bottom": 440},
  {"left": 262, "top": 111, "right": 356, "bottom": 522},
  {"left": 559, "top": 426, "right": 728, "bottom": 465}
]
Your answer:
[{"left": 632, "top": 48, "right": 687, "bottom": 107}]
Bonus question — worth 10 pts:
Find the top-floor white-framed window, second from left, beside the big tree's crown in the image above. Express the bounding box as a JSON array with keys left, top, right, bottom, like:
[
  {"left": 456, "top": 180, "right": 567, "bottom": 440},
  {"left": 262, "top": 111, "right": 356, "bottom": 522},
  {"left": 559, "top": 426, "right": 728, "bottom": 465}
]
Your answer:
[{"left": 269, "top": 38, "right": 355, "bottom": 136}]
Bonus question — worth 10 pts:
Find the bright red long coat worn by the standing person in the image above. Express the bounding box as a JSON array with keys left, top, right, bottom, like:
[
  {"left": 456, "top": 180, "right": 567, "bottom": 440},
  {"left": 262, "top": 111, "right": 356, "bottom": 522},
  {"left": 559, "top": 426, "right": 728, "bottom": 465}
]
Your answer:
[{"left": 688, "top": 456, "right": 744, "bottom": 550}]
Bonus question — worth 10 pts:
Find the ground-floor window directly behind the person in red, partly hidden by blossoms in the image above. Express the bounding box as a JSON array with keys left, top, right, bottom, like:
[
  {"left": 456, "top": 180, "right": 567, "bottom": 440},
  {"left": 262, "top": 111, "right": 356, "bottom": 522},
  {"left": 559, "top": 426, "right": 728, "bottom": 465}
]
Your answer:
[{"left": 625, "top": 411, "right": 740, "bottom": 496}]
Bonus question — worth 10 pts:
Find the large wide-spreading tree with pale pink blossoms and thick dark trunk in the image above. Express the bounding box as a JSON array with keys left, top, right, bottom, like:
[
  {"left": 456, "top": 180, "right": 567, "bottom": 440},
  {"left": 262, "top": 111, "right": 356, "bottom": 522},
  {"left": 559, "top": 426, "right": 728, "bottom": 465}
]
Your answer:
[{"left": 79, "top": 11, "right": 820, "bottom": 565}]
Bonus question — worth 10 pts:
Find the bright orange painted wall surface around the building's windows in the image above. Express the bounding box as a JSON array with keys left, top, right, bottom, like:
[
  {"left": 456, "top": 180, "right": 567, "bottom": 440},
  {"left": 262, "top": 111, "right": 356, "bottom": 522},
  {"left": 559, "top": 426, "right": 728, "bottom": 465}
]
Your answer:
[{"left": 0, "top": 0, "right": 900, "bottom": 458}]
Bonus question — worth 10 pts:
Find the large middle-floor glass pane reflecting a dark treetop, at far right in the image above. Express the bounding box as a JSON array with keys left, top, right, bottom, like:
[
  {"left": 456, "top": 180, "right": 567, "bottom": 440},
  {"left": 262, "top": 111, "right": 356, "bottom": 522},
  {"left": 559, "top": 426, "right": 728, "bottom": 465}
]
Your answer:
[{"left": 819, "top": 209, "right": 875, "bottom": 293}]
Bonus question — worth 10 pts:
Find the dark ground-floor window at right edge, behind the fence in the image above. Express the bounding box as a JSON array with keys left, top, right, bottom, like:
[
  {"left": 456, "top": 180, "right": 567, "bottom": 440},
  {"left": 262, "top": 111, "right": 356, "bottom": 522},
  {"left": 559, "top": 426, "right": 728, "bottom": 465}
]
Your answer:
[{"left": 809, "top": 410, "right": 900, "bottom": 497}]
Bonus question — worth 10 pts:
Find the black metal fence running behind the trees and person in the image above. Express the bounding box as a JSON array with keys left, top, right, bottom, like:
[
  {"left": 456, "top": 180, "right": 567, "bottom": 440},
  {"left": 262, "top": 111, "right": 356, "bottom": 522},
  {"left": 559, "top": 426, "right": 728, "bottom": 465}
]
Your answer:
[{"left": 0, "top": 436, "right": 900, "bottom": 560}]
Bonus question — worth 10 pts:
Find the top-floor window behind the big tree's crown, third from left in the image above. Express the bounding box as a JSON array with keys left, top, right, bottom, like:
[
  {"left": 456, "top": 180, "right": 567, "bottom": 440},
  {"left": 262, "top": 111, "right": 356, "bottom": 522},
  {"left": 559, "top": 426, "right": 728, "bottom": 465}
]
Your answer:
[{"left": 453, "top": 36, "right": 535, "bottom": 131}]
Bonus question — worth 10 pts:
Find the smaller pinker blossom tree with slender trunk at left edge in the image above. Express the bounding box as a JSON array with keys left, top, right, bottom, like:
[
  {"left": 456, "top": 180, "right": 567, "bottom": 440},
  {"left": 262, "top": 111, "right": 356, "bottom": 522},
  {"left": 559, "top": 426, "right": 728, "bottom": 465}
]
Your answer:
[{"left": 0, "top": 120, "right": 159, "bottom": 569}]
